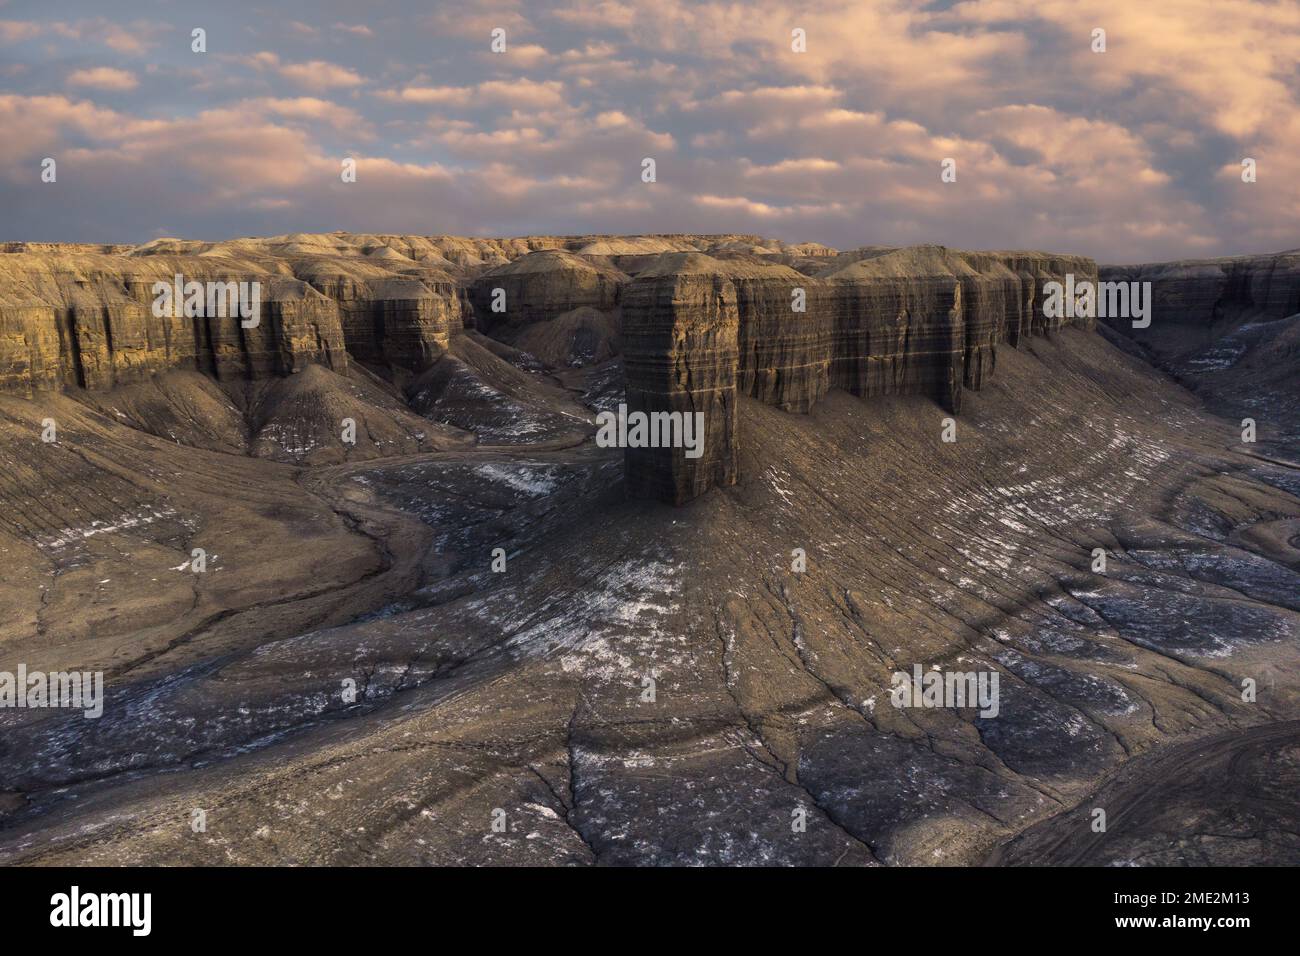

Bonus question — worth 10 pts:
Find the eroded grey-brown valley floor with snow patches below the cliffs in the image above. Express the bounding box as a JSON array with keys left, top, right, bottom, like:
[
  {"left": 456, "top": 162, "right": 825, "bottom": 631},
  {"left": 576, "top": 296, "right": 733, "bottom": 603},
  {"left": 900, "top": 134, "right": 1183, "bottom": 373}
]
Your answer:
[{"left": 0, "top": 329, "right": 1300, "bottom": 865}]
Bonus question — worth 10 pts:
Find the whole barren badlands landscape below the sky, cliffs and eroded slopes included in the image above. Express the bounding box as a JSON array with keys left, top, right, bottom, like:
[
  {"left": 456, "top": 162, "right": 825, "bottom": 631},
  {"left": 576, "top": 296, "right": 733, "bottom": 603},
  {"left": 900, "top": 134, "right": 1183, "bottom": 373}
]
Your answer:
[{"left": 0, "top": 233, "right": 1300, "bottom": 865}]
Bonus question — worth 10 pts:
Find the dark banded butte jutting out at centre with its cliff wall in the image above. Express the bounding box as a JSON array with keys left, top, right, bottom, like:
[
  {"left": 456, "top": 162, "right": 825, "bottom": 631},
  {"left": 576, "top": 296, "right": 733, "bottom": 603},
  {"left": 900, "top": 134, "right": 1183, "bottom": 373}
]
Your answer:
[{"left": 621, "top": 246, "right": 1097, "bottom": 503}]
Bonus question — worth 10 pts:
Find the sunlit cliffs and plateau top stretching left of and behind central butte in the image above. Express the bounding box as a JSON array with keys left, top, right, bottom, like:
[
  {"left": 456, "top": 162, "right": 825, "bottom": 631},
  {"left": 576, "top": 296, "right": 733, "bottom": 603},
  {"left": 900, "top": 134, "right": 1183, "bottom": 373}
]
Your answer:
[{"left": 0, "top": 233, "right": 780, "bottom": 397}]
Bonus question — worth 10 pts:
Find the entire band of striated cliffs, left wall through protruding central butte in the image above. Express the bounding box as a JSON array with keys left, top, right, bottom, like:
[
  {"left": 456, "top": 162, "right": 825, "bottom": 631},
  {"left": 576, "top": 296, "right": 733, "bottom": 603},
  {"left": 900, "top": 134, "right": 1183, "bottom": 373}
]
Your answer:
[{"left": 0, "top": 233, "right": 1107, "bottom": 503}]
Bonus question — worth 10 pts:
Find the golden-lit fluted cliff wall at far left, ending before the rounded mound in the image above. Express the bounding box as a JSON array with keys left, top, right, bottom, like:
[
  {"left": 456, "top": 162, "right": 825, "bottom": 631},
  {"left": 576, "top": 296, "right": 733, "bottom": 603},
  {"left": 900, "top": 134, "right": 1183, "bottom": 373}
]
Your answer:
[{"left": 0, "top": 235, "right": 493, "bottom": 395}]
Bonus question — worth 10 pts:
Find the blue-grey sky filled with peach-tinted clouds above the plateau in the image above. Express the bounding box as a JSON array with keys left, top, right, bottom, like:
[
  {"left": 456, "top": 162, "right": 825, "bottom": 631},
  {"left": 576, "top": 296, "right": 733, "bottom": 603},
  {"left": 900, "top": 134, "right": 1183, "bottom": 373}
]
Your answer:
[{"left": 0, "top": 0, "right": 1300, "bottom": 263}]
